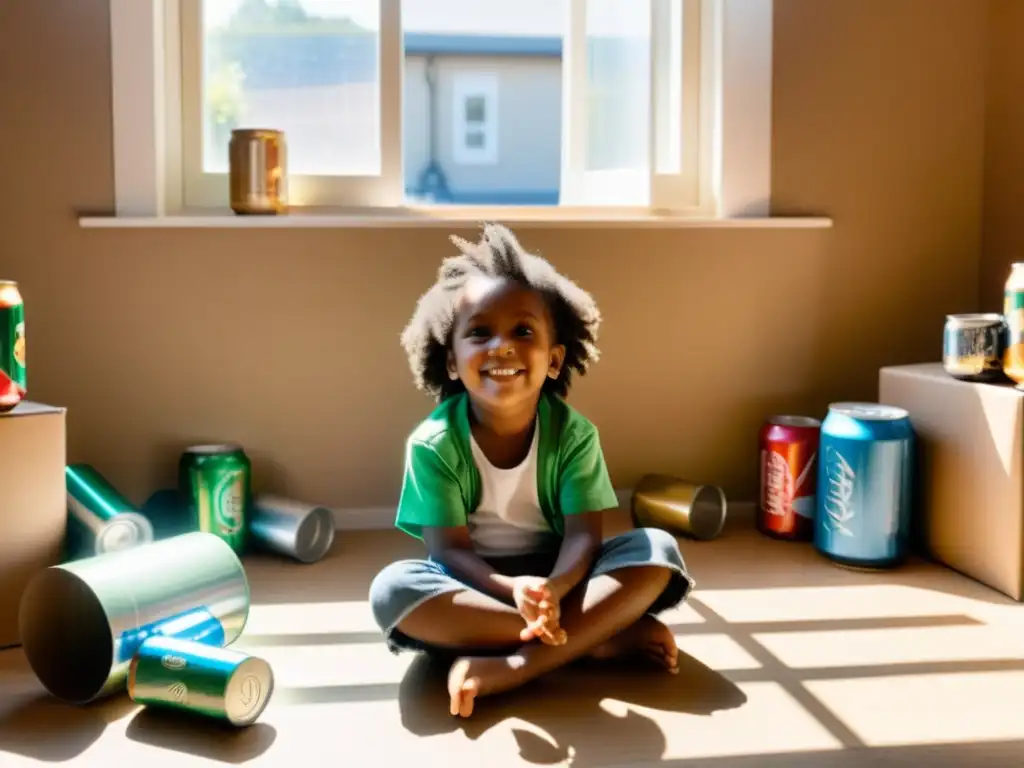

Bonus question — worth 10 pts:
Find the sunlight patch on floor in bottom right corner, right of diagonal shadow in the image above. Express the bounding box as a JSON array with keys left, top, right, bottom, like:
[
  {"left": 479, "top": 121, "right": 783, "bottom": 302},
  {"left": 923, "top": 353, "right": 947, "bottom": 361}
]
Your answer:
[{"left": 804, "top": 672, "right": 1024, "bottom": 746}]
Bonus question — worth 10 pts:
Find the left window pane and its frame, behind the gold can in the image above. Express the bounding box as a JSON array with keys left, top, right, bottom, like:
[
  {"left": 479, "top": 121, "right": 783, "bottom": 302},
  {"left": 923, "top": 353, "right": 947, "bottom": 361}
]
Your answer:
[{"left": 179, "top": 0, "right": 401, "bottom": 208}]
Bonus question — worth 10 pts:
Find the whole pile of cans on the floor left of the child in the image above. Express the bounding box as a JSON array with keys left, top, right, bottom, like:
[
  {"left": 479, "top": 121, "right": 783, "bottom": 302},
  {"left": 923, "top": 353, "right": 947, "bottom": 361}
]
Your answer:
[{"left": 48, "top": 443, "right": 335, "bottom": 726}]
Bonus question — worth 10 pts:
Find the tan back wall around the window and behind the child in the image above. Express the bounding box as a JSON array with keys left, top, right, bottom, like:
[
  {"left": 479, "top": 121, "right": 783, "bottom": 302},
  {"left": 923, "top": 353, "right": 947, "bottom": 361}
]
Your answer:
[{"left": 0, "top": 0, "right": 987, "bottom": 518}]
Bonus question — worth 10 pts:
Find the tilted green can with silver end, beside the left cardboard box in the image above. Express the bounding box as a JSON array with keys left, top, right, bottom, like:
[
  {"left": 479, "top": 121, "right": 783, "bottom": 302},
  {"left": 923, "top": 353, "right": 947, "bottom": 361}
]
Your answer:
[{"left": 65, "top": 464, "right": 154, "bottom": 559}]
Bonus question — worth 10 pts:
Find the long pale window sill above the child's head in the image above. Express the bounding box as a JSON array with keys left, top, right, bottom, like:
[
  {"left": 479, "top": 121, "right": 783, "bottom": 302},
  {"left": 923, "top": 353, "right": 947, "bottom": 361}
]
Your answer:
[{"left": 78, "top": 206, "right": 833, "bottom": 229}]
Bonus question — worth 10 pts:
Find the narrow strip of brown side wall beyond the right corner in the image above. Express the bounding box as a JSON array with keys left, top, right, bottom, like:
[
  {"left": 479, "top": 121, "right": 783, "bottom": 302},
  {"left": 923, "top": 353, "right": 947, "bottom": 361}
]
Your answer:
[{"left": 981, "top": 0, "right": 1024, "bottom": 311}]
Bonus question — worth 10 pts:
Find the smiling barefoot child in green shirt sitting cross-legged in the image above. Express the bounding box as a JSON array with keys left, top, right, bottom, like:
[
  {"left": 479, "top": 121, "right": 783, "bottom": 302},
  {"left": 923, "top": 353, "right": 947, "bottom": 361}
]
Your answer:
[{"left": 370, "top": 224, "right": 693, "bottom": 717}]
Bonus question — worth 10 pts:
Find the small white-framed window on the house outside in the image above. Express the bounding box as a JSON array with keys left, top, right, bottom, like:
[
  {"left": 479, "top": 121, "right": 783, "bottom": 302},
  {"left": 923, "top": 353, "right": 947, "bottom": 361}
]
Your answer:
[{"left": 452, "top": 72, "right": 499, "bottom": 165}]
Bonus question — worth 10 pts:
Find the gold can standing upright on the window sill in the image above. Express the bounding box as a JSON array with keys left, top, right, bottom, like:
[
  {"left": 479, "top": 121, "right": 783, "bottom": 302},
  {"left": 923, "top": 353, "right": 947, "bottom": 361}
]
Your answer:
[{"left": 228, "top": 128, "right": 288, "bottom": 215}]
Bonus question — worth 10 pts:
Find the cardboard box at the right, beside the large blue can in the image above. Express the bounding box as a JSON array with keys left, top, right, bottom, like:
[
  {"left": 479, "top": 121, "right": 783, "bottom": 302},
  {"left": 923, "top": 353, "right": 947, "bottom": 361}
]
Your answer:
[{"left": 879, "top": 364, "right": 1024, "bottom": 601}]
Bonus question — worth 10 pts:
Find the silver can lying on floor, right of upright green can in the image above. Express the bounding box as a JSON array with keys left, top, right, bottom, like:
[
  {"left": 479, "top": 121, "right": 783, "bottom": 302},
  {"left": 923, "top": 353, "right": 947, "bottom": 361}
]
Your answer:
[{"left": 249, "top": 495, "right": 334, "bottom": 563}]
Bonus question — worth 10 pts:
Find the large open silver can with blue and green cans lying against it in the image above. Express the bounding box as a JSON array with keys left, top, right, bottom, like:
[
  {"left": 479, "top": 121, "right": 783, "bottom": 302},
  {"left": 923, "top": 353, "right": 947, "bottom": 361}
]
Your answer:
[{"left": 18, "top": 531, "right": 273, "bottom": 726}]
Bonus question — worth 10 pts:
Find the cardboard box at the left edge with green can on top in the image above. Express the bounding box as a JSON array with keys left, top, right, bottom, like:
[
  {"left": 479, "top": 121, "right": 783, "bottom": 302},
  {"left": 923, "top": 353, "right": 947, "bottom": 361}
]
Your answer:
[{"left": 0, "top": 402, "right": 68, "bottom": 648}]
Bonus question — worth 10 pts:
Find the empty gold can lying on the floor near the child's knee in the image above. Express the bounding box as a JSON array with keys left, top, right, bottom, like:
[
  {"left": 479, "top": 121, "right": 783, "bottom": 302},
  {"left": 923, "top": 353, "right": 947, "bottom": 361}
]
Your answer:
[{"left": 630, "top": 474, "right": 727, "bottom": 541}]
